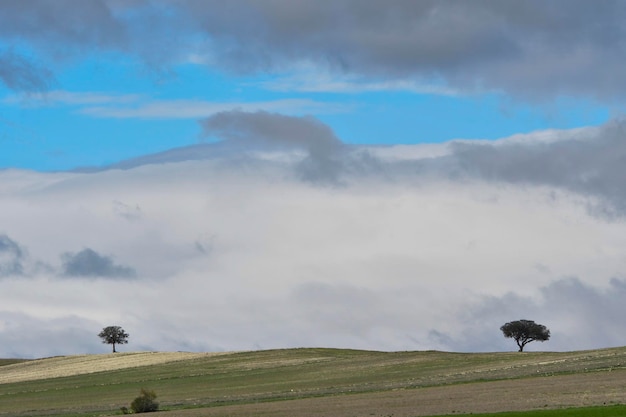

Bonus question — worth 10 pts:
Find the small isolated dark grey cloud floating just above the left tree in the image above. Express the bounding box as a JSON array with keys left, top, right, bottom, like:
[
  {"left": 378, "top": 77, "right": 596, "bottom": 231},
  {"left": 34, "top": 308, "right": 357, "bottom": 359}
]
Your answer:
[{"left": 62, "top": 248, "right": 136, "bottom": 278}]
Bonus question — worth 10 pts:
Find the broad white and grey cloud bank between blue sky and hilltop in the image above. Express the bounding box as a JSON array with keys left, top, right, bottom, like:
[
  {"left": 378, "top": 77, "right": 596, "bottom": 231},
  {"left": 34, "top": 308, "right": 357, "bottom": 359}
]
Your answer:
[{"left": 0, "top": 111, "right": 626, "bottom": 357}]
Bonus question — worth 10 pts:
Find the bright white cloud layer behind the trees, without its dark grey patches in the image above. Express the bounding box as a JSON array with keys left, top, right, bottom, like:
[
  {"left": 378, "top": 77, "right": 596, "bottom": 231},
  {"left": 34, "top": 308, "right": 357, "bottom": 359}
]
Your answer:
[{"left": 0, "top": 145, "right": 626, "bottom": 356}]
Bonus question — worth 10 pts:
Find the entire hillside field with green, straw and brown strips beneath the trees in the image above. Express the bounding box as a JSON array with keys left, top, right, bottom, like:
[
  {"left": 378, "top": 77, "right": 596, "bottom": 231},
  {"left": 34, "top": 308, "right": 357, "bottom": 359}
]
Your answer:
[{"left": 0, "top": 348, "right": 626, "bottom": 417}]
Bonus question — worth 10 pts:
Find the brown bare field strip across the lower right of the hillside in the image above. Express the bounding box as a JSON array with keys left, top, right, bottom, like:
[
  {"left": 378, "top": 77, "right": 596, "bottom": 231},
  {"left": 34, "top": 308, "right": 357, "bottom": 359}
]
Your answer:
[{"left": 149, "top": 370, "right": 626, "bottom": 417}]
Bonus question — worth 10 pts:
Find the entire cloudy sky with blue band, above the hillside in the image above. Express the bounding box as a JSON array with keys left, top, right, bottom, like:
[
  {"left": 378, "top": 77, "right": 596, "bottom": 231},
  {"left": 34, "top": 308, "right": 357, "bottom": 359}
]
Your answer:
[{"left": 0, "top": 0, "right": 626, "bottom": 358}]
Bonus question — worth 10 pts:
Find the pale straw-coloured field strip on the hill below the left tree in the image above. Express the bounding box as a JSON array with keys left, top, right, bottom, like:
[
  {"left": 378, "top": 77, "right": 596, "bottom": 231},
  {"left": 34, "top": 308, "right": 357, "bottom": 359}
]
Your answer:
[{"left": 0, "top": 352, "right": 232, "bottom": 384}]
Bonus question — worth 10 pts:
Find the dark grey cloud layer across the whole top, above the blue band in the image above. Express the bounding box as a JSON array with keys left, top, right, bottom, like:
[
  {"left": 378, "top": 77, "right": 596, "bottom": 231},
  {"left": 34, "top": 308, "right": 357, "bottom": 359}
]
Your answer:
[{"left": 0, "top": 0, "right": 626, "bottom": 100}]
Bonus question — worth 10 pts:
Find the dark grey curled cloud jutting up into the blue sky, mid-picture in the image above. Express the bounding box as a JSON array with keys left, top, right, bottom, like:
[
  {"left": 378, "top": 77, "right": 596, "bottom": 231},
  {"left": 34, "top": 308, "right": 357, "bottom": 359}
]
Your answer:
[{"left": 201, "top": 110, "right": 342, "bottom": 181}]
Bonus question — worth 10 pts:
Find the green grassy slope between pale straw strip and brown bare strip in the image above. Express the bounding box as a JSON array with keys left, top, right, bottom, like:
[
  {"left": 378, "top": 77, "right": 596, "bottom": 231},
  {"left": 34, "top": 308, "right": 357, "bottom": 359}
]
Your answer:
[{"left": 0, "top": 348, "right": 626, "bottom": 417}]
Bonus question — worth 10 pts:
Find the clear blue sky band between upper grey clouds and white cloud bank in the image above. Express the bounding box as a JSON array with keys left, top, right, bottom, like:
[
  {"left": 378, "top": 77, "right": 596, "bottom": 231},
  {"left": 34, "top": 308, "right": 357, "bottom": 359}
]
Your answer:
[{"left": 0, "top": 57, "right": 610, "bottom": 170}]
